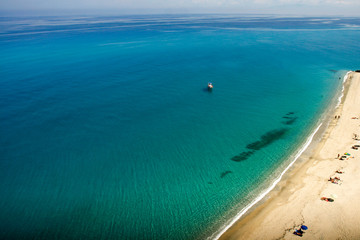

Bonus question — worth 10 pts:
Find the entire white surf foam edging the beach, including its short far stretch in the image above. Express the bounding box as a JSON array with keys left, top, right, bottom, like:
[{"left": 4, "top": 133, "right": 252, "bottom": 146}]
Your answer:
[{"left": 207, "top": 71, "right": 351, "bottom": 240}]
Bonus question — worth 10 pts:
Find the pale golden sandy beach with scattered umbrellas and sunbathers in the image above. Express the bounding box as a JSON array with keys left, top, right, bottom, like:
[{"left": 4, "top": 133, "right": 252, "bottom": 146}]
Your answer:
[{"left": 221, "top": 72, "right": 360, "bottom": 239}]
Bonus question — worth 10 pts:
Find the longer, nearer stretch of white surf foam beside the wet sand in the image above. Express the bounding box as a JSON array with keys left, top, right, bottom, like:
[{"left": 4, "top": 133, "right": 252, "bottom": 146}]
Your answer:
[{"left": 208, "top": 123, "right": 322, "bottom": 240}]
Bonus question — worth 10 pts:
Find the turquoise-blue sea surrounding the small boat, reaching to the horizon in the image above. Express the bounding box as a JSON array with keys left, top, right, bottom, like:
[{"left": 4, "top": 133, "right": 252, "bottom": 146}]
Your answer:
[{"left": 0, "top": 15, "right": 360, "bottom": 239}]
